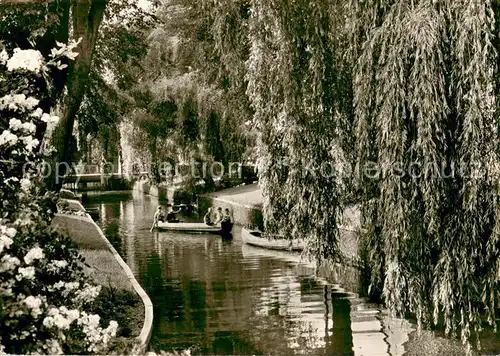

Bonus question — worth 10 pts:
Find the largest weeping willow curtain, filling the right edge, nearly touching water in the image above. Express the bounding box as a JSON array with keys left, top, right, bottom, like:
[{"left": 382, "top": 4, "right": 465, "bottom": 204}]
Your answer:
[{"left": 350, "top": 0, "right": 500, "bottom": 350}]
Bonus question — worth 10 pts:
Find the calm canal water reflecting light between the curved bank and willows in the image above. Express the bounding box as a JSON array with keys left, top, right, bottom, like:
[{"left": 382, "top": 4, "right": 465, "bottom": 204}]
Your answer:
[{"left": 87, "top": 194, "right": 500, "bottom": 356}]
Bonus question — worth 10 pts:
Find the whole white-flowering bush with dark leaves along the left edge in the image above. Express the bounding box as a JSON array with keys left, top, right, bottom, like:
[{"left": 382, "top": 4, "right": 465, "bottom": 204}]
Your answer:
[{"left": 0, "top": 42, "right": 118, "bottom": 354}]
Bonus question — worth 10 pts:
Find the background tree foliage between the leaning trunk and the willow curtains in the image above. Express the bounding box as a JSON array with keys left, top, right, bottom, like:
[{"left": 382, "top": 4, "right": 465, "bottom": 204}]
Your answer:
[{"left": 72, "top": 0, "right": 254, "bottom": 182}]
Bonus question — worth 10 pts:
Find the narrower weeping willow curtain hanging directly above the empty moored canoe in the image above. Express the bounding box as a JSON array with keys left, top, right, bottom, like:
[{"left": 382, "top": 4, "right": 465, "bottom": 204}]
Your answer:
[{"left": 247, "top": 0, "right": 350, "bottom": 260}]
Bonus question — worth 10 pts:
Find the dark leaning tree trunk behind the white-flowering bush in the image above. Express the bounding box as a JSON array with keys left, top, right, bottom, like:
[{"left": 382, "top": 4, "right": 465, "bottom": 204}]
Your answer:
[{"left": 49, "top": 0, "right": 107, "bottom": 191}]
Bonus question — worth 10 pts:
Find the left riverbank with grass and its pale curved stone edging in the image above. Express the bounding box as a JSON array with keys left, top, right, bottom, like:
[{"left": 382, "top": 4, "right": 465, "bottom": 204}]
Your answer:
[{"left": 52, "top": 200, "right": 153, "bottom": 354}]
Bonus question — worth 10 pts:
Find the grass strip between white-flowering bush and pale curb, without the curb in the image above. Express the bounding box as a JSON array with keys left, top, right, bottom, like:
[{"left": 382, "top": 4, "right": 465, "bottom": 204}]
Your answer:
[{"left": 52, "top": 211, "right": 145, "bottom": 354}]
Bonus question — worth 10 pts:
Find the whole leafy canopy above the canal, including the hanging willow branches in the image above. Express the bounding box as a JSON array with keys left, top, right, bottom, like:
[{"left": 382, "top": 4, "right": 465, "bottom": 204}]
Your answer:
[{"left": 0, "top": 0, "right": 500, "bottom": 350}]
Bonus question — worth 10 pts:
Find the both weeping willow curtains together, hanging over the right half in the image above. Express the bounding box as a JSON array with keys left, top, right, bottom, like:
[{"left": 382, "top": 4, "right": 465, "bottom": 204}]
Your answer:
[{"left": 246, "top": 0, "right": 500, "bottom": 350}]
